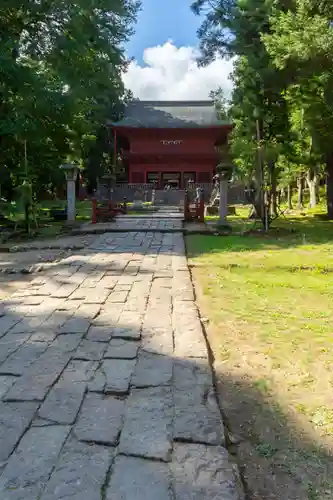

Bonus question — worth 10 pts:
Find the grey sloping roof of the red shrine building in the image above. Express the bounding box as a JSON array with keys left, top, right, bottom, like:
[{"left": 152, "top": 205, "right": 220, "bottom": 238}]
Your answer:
[{"left": 109, "top": 100, "right": 229, "bottom": 128}]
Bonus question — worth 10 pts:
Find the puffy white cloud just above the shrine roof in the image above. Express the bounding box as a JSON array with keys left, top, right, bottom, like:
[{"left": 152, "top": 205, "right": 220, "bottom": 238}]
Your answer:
[{"left": 123, "top": 41, "right": 232, "bottom": 100}]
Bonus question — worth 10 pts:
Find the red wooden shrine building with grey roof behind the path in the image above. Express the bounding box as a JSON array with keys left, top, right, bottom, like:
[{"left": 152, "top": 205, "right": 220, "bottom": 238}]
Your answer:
[{"left": 109, "top": 100, "right": 232, "bottom": 189}]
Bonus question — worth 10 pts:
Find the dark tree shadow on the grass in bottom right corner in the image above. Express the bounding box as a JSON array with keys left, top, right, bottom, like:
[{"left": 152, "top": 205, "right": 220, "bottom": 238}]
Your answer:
[{"left": 215, "top": 363, "right": 333, "bottom": 500}]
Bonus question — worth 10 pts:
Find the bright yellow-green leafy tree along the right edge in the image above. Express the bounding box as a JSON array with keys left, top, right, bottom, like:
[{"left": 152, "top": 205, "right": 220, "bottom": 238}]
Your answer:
[{"left": 263, "top": 0, "right": 333, "bottom": 219}]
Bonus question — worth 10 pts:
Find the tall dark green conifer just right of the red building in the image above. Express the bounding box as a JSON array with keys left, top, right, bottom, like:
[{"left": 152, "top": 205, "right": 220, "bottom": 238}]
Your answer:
[{"left": 192, "top": 0, "right": 289, "bottom": 220}]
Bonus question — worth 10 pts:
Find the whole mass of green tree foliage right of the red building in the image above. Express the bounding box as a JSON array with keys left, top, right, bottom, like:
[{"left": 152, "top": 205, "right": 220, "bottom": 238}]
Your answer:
[{"left": 192, "top": 0, "right": 333, "bottom": 217}]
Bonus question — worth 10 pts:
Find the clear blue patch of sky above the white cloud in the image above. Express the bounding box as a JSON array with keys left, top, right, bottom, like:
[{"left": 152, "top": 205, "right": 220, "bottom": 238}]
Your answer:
[{"left": 127, "top": 0, "right": 200, "bottom": 63}]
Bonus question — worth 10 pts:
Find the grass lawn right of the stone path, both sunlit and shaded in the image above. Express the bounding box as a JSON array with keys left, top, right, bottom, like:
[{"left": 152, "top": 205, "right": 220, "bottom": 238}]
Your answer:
[{"left": 186, "top": 214, "right": 333, "bottom": 500}]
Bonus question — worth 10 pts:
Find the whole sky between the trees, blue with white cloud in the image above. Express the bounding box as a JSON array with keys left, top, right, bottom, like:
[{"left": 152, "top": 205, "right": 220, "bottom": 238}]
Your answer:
[{"left": 123, "top": 0, "right": 232, "bottom": 100}]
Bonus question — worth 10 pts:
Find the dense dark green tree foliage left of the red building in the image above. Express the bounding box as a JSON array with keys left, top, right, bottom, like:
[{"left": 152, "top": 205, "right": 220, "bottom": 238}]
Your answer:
[{"left": 0, "top": 0, "right": 139, "bottom": 199}]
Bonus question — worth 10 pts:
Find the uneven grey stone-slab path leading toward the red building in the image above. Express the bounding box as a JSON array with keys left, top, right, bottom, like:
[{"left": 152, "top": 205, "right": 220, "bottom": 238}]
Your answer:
[{"left": 0, "top": 232, "right": 244, "bottom": 500}]
